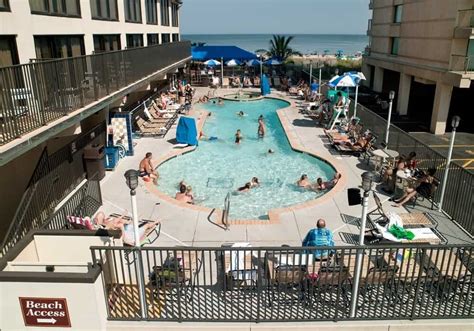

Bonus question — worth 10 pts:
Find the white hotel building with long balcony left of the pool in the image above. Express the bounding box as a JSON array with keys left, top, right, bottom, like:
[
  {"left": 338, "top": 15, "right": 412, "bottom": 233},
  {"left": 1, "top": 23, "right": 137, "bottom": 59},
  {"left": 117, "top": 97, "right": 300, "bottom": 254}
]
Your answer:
[{"left": 0, "top": 0, "right": 190, "bottom": 238}]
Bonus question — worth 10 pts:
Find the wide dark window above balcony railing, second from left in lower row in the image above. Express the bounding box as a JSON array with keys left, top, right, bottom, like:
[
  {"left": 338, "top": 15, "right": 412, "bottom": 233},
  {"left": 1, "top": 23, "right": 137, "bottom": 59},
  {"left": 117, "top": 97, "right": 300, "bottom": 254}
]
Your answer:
[{"left": 34, "top": 35, "right": 85, "bottom": 59}]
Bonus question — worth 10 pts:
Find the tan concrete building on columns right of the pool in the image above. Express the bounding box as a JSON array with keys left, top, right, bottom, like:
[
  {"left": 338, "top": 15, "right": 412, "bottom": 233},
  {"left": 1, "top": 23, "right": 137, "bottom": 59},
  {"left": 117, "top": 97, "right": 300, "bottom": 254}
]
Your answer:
[{"left": 363, "top": 0, "right": 474, "bottom": 134}]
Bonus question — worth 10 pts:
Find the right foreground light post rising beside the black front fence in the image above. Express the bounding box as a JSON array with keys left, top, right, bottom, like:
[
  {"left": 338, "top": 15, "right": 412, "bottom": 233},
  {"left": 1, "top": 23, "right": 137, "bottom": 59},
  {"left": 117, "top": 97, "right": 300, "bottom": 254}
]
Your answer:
[{"left": 350, "top": 171, "right": 374, "bottom": 317}]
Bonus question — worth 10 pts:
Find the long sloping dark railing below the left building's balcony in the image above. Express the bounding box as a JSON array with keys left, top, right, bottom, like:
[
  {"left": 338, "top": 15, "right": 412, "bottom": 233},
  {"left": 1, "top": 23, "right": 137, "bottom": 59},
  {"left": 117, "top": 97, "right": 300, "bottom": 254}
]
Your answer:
[{"left": 1, "top": 122, "right": 106, "bottom": 254}]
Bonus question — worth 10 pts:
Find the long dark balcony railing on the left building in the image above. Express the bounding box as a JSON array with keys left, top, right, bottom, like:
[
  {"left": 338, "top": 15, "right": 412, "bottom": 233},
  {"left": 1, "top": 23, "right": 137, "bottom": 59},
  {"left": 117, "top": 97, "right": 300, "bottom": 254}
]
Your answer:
[{"left": 0, "top": 42, "right": 191, "bottom": 145}]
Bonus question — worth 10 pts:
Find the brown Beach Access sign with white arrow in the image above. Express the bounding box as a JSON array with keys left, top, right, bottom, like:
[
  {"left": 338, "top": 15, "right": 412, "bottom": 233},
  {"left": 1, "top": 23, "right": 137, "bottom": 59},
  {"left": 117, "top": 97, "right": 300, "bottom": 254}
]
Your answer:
[{"left": 19, "top": 298, "right": 71, "bottom": 328}]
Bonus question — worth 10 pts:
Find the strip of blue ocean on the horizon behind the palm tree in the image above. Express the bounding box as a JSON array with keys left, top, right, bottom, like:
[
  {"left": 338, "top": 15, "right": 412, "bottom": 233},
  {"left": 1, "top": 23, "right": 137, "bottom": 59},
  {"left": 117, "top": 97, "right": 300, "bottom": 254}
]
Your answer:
[{"left": 181, "top": 34, "right": 369, "bottom": 55}]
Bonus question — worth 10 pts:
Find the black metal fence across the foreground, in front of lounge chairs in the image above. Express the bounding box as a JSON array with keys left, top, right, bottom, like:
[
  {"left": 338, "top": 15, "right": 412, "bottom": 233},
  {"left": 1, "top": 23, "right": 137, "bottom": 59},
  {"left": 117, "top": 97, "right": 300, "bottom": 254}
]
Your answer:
[{"left": 91, "top": 244, "right": 474, "bottom": 322}]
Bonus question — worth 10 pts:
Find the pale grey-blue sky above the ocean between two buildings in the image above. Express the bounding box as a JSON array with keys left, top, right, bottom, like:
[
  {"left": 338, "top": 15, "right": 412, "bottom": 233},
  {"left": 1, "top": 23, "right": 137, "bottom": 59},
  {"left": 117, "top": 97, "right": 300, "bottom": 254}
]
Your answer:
[{"left": 180, "top": 0, "right": 371, "bottom": 34}]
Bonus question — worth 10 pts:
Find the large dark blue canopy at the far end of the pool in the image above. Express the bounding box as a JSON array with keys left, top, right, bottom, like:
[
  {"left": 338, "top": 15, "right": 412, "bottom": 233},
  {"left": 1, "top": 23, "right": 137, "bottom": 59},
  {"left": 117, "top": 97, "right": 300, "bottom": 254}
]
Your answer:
[{"left": 191, "top": 46, "right": 257, "bottom": 61}]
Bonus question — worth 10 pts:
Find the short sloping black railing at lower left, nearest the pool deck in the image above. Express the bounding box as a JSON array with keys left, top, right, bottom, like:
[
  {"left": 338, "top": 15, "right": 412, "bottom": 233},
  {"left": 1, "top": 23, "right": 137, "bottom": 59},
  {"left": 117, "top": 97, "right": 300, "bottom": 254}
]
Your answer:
[{"left": 41, "top": 180, "right": 102, "bottom": 230}]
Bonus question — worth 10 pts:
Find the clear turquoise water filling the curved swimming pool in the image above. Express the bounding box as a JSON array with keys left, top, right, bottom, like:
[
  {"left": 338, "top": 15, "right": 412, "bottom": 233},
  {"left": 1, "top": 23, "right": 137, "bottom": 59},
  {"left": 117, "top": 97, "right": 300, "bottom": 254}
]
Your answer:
[{"left": 158, "top": 99, "right": 335, "bottom": 219}]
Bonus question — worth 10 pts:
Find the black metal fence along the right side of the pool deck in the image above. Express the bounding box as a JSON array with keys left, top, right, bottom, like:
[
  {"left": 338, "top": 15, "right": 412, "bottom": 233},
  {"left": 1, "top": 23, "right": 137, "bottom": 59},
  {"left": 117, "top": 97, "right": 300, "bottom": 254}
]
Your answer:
[{"left": 357, "top": 104, "right": 474, "bottom": 236}]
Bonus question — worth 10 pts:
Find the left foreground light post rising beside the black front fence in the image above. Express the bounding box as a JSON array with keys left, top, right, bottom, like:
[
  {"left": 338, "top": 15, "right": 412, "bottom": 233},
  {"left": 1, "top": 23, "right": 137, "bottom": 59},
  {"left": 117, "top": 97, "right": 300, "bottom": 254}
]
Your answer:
[{"left": 124, "top": 169, "right": 147, "bottom": 318}]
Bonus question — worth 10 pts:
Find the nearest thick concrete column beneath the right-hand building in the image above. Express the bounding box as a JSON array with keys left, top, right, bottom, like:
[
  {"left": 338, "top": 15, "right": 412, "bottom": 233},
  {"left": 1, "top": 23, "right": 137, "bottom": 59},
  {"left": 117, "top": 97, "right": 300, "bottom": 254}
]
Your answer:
[{"left": 430, "top": 82, "right": 453, "bottom": 134}]
